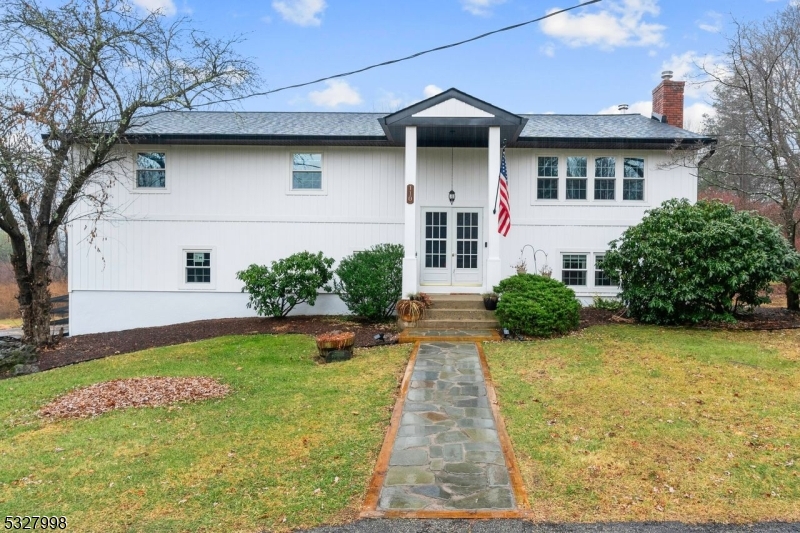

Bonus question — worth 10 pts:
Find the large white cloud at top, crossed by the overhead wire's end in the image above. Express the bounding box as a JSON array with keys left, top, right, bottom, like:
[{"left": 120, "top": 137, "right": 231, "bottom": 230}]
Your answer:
[{"left": 539, "top": 0, "right": 666, "bottom": 50}]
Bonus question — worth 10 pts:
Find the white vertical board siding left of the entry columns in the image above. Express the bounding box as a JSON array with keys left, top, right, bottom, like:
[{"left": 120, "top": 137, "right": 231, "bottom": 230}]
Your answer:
[{"left": 70, "top": 146, "right": 405, "bottom": 334}]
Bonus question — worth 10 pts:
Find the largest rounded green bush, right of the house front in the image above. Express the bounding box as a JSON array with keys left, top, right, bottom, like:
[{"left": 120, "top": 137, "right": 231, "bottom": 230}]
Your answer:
[{"left": 603, "top": 200, "right": 798, "bottom": 324}]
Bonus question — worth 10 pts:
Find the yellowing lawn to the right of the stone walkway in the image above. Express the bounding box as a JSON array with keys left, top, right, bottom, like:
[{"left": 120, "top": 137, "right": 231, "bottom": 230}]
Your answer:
[{"left": 485, "top": 326, "right": 800, "bottom": 522}]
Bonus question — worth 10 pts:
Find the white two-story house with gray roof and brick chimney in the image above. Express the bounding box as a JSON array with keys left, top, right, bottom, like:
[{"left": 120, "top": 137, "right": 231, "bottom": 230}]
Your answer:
[{"left": 69, "top": 77, "right": 711, "bottom": 335}]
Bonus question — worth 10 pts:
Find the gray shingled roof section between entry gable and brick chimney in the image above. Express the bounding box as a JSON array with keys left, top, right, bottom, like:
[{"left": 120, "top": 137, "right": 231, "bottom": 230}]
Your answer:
[{"left": 520, "top": 113, "right": 705, "bottom": 139}]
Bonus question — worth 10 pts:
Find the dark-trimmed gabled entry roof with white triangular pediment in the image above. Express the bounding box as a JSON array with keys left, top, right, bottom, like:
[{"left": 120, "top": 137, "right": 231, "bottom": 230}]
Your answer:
[{"left": 378, "top": 88, "right": 528, "bottom": 146}]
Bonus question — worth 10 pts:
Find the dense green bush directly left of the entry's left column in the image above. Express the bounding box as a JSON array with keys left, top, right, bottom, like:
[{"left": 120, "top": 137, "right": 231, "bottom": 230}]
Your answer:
[{"left": 334, "top": 244, "right": 404, "bottom": 320}]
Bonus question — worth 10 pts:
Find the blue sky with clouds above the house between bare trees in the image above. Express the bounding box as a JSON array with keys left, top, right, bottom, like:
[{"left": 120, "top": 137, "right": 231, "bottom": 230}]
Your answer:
[{"left": 134, "top": 0, "right": 796, "bottom": 129}]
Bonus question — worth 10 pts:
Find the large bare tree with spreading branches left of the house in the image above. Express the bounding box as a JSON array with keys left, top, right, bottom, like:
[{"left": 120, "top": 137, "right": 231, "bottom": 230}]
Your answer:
[{"left": 0, "top": 0, "right": 258, "bottom": 345}]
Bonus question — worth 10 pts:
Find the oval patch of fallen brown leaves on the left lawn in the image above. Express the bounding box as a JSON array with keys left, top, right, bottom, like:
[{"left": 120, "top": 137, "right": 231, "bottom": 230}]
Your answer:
[{"left": 39, "top": 377, "right": 230, "bottom": 418}]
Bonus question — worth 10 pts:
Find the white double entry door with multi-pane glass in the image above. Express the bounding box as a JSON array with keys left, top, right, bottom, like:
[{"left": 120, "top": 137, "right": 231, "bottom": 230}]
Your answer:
[{"left": 420, "top": 207, "right": 483, "bottom": 286}]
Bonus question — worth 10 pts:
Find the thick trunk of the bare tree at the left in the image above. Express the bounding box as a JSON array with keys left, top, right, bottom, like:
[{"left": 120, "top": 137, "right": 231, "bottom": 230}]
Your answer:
[{"left": 11, "top": 247, "right": 52, "bottom": 346}]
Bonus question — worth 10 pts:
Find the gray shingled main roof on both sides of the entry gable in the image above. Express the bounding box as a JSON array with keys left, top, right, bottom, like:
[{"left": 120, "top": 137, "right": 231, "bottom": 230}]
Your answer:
[{"left": 129, "top": 111, "right": 705, "bottom": 140}]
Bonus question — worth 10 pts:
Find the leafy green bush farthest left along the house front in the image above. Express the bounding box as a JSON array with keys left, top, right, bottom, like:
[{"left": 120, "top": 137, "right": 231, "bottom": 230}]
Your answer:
[{"left": 236, "top": 252, "right": 333, "bottom": 317}]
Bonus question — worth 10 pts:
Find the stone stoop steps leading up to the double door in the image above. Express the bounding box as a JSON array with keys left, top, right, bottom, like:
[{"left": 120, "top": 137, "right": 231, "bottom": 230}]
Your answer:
[{"left": 399, "top": 294, "right": 500, "bottom": 342}]
